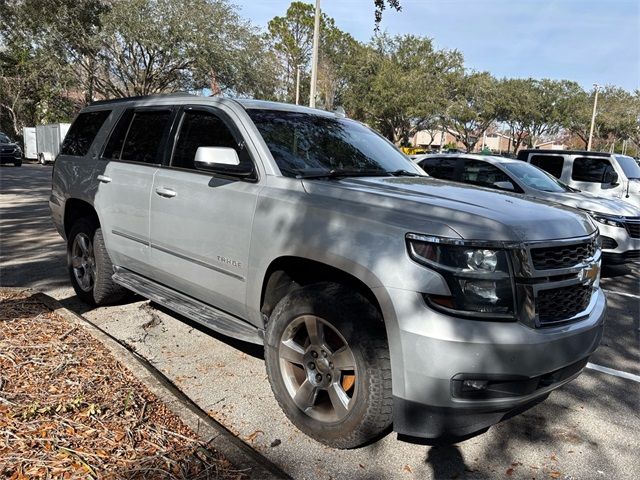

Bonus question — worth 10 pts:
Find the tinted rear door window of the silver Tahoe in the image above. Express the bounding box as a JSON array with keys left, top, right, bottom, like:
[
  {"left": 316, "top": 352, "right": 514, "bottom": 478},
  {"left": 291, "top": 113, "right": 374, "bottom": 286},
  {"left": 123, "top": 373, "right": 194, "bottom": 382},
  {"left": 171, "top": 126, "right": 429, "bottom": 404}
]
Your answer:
[{"left": 102, "top": 110, "right": 171, "bottom": 164}]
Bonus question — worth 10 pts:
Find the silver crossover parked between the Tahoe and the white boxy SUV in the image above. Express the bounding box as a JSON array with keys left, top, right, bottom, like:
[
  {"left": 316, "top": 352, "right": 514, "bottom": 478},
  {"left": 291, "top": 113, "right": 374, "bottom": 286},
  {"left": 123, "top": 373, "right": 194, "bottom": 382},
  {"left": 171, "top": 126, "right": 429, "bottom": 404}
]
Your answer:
[{"left": 416, "top": 154, "right": 640, "bottom": 264}]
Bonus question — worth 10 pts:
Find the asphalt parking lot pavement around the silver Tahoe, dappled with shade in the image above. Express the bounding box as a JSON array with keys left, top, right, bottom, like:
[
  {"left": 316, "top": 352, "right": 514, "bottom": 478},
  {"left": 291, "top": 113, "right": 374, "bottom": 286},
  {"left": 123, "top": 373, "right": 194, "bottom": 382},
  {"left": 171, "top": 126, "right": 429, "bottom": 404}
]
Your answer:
[{"left": 0, "top": 164, "right": 640, "bottom": 480}]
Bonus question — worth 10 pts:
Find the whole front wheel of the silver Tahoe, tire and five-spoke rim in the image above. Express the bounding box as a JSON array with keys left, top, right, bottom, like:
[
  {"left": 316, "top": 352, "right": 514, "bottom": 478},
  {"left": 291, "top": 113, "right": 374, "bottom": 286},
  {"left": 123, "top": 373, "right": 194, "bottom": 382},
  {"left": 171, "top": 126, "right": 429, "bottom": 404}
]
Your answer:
[{"left": 265, "top": 283, "right": 392, "bottom": 448}]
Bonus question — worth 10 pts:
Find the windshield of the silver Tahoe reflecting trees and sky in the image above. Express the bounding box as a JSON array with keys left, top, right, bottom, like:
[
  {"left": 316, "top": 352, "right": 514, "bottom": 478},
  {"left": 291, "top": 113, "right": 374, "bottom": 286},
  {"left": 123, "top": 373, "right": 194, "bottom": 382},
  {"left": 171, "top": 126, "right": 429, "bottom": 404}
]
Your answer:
[{"left": 248, "top": 109, "right": 424, "bottom": 177}]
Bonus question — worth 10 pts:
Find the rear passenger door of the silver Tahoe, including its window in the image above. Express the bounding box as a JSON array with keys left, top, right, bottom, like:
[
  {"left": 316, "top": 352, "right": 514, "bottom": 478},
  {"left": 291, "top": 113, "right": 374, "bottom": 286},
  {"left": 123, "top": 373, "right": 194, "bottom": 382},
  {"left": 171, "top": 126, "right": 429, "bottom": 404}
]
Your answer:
[{"left": 94, "top": 107, "right": 173, "bottom": 275}]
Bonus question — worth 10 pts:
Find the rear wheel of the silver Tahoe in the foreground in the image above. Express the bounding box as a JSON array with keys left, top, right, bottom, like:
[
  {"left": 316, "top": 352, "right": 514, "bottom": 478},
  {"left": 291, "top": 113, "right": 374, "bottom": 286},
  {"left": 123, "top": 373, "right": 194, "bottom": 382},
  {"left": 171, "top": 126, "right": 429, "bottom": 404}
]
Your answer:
[{"left": 67, "top": 218, "right": 127, "bottom": 305}]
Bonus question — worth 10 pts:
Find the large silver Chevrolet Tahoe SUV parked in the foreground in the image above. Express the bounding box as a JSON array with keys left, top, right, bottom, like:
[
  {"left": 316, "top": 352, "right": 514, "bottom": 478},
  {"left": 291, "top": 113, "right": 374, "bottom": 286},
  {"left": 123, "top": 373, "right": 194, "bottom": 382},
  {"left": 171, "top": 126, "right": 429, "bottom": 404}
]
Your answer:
[{"left": 50, "top": 95, "right": 606, "bottom": 448}]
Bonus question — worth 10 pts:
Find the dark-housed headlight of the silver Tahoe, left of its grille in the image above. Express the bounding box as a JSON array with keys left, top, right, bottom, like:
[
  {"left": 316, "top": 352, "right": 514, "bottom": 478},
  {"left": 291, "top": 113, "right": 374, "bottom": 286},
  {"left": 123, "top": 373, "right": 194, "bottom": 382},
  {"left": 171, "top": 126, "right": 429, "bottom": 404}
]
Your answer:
[{"left": 406, "top": 233, "right": 515, "bottom": 320}]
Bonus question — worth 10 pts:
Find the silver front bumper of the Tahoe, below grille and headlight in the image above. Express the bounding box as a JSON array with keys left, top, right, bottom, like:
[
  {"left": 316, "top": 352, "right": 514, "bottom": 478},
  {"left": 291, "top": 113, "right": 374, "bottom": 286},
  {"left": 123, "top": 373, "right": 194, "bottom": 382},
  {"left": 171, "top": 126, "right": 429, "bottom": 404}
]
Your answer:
[{"left": 385, "top": 289, "right": 606, "bottom": 439}]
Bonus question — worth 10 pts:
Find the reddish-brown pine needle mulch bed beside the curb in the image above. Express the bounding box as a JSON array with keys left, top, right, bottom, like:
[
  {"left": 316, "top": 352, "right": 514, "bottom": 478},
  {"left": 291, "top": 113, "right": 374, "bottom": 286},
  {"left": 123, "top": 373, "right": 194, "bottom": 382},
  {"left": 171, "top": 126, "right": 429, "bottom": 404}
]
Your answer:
[{"left": 0, "top": 291, "right": 245, "bottom": 480}]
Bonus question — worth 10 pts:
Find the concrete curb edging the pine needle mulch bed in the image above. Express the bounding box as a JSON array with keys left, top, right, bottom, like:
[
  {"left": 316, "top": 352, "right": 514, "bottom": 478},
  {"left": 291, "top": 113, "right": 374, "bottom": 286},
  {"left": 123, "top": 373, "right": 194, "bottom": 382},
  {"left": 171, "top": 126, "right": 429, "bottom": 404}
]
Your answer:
[{"left": 1, "top": 287, "right": 291, "bottom": 479}]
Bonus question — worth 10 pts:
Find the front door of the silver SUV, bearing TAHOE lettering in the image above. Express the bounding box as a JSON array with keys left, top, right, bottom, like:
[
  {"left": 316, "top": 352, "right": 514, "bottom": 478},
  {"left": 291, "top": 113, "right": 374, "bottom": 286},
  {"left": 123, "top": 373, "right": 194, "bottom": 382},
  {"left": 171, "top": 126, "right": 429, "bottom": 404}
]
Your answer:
[{"left": 150, "top": 107, "right": 261, "bottom": 317}]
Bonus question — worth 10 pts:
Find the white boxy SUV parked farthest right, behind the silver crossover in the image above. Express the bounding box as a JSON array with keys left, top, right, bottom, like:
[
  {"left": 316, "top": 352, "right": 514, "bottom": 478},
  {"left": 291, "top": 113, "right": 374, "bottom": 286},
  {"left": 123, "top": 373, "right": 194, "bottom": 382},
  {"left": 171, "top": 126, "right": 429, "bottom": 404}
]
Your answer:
[{"left": 518, "top": 150, "right": 640, "bottom": 207}]
